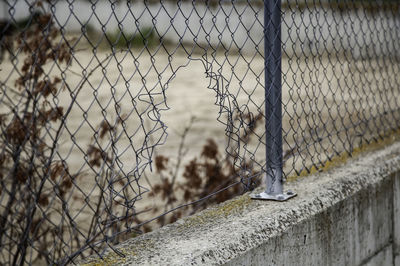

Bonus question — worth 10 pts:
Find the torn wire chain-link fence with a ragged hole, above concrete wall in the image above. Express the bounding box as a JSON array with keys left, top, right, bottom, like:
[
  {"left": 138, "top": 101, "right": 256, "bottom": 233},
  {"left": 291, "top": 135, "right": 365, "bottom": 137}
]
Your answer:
[{"left": 0, "top": 0, "right": 400, "bottom": 265}]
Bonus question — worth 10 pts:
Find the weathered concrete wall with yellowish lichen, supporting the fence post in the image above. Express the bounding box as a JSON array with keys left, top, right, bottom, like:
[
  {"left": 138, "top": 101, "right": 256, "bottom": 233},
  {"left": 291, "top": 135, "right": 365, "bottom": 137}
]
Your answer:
[{"left": 81, "top": 140, "right": 400, "bottom": 265}]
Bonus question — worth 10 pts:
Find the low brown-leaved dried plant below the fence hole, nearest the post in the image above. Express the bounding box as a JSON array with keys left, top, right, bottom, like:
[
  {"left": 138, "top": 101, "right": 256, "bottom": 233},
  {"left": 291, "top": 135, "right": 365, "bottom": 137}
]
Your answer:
[{"left": 146, "top": 113, "right": 263, "bottom": 226}]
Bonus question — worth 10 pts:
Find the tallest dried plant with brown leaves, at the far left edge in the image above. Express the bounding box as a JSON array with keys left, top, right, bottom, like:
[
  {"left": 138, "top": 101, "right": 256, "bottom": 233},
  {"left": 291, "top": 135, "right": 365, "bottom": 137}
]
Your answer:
[{"left": 0, "top": 4, "right": 80, "bottom": 264}]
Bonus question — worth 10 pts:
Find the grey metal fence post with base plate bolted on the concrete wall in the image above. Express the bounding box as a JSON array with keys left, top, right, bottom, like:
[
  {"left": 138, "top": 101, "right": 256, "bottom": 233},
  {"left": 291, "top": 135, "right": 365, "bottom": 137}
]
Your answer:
[{"left": 252, "top": 0, "right": 296, "bottom": 201}]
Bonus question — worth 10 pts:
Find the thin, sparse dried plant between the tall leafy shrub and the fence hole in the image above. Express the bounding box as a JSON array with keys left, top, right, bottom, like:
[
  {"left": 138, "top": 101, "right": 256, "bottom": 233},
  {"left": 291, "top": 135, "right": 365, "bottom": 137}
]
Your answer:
[{"left": 81, "top": 115, "right": 147, "bottom": 243}]
